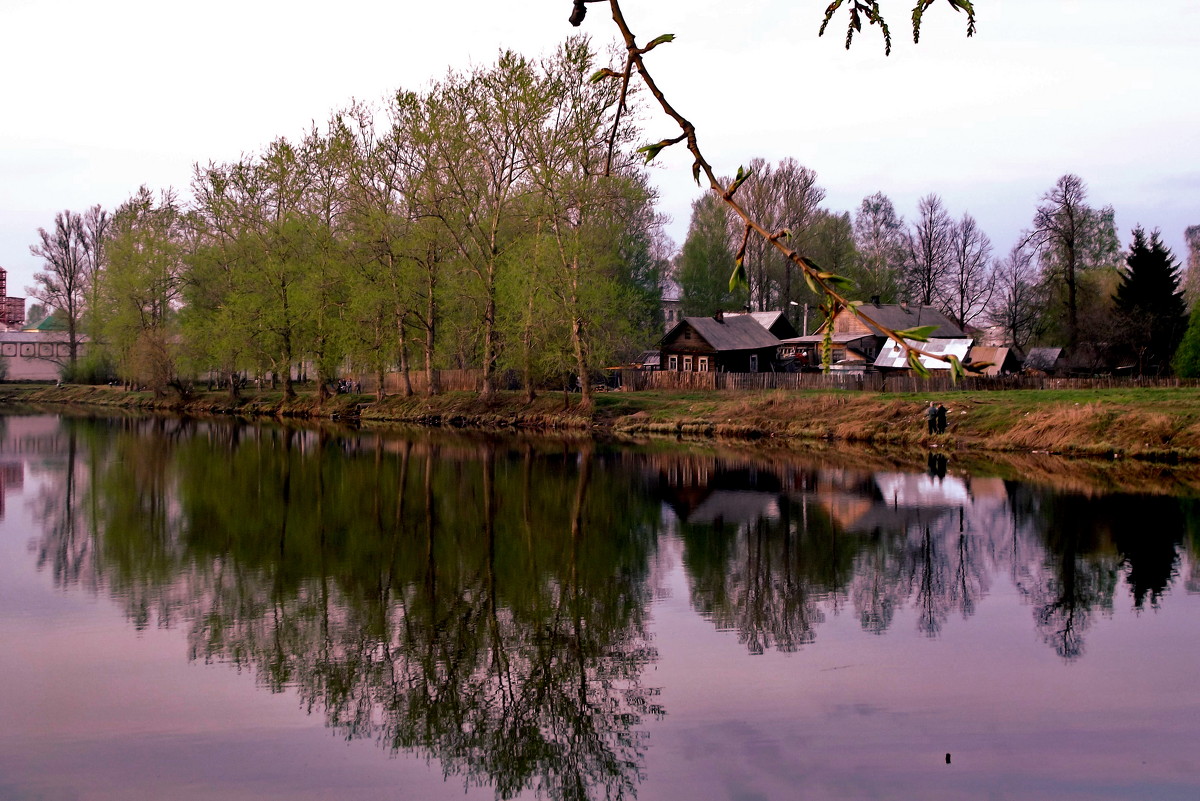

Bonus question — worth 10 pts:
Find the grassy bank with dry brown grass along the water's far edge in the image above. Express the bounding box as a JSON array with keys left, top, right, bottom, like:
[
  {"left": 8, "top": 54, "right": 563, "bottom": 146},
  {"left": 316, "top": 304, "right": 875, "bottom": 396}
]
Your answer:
[{"left": 0, "top": 385, "right": 1200, "bottom": 462}]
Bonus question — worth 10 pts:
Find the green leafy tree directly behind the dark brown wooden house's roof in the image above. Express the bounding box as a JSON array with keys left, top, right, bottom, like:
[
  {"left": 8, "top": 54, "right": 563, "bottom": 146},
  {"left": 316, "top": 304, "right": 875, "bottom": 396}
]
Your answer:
[{"left": 676, "top": 193, "right": 746, "bottom": 317}]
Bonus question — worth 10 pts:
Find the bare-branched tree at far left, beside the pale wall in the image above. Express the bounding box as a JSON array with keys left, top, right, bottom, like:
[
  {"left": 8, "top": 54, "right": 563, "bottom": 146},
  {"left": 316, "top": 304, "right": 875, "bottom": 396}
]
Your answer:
[{"left": 26, "top": 210, "right": 88, "bottom": 372}]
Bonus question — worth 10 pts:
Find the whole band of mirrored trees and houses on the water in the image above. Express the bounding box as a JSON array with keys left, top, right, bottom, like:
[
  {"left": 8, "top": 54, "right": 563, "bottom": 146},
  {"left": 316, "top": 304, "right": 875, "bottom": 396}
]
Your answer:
[{"left": 11, "top": 418, "right": 1200, "bottom": 799}]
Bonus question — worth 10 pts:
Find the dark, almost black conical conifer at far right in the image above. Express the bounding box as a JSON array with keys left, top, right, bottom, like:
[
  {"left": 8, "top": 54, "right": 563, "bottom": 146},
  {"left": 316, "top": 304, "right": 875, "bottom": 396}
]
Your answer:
[{"left": 1115, "top": 227, "right": 1188, "bottom": 374}]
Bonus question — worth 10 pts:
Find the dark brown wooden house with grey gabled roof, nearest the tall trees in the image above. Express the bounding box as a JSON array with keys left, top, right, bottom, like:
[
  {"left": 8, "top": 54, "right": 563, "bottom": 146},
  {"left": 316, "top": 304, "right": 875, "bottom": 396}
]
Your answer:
[{"left": 659, "top": 312, "right": 780, "bottom": 373}]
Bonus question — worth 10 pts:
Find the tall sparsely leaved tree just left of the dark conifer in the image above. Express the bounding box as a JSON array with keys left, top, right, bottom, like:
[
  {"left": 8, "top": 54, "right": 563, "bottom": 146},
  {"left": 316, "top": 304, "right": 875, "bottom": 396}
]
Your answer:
[{"left": 1026, "top": 174, "right": 1118, "bottom": 345}]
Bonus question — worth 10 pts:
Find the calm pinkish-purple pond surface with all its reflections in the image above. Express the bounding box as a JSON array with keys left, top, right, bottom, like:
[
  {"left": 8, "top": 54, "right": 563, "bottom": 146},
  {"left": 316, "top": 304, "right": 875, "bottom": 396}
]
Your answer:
[{"left": 0, "top": 416, "right": 1200, "bottom": 801}]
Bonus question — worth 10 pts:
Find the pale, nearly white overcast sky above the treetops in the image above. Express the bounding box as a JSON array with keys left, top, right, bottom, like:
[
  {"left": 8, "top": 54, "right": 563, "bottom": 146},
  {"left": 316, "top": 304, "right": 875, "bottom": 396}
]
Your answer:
[{"left": 0, "top": 0, "right": 1200, "bottom": 295}]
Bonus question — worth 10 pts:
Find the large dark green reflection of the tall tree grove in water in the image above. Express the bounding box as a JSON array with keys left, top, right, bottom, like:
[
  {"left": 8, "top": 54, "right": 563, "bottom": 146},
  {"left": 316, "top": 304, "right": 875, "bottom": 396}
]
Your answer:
[{"left": 30, "top": 421, "right": 662, "bottom": 799}]
